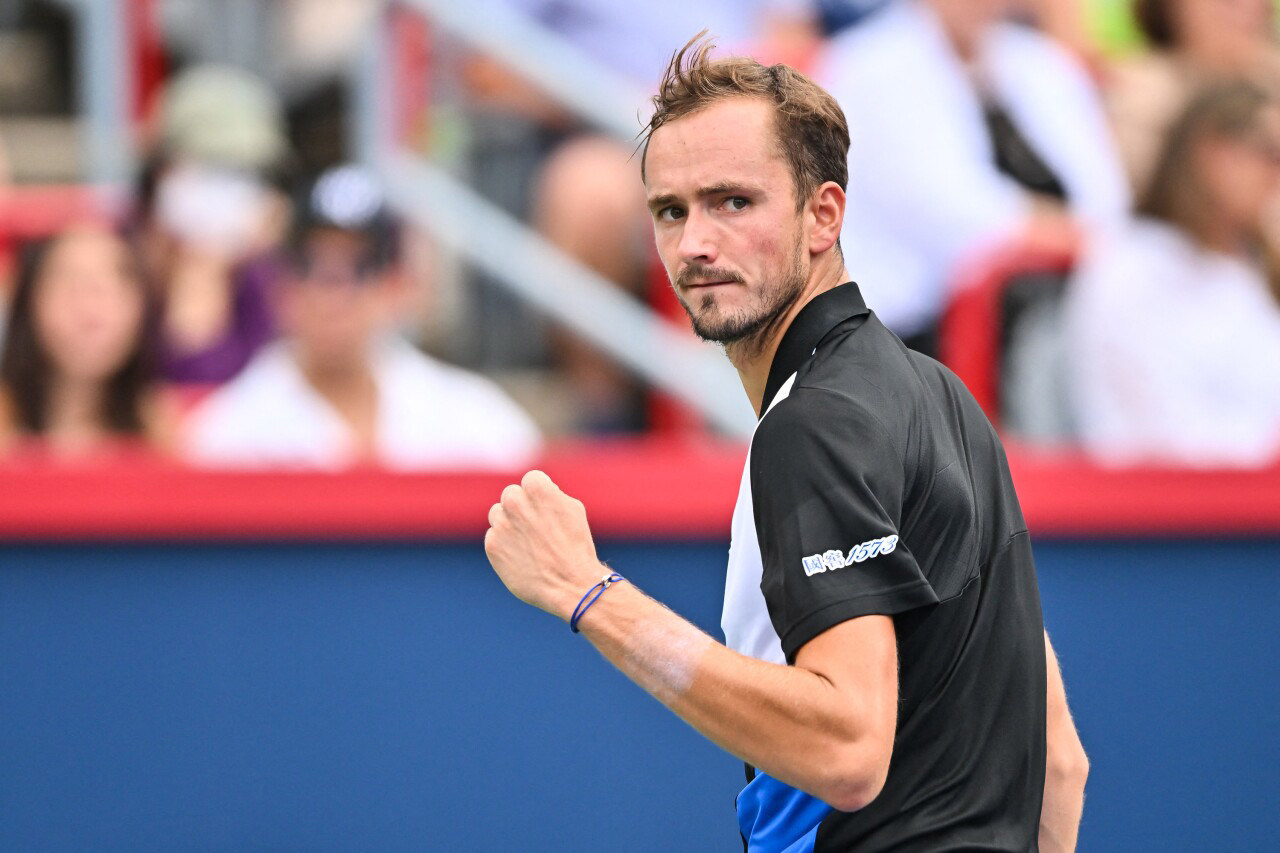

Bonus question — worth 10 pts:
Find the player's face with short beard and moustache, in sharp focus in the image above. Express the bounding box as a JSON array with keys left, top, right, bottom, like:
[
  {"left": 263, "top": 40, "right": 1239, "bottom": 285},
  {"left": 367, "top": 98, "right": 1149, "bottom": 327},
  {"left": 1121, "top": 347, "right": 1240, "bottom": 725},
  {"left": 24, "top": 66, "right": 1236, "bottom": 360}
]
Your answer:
[{"left": 645, "top": 97, "right": 809, "bottom": 343}]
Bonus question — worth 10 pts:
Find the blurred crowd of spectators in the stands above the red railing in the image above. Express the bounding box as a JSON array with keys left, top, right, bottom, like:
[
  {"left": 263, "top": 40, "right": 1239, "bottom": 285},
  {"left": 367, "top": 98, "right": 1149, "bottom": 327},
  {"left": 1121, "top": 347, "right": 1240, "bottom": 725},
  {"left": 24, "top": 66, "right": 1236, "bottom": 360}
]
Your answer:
[{"left": 0, "top": 0, "right": 1280, "bottom": 470}]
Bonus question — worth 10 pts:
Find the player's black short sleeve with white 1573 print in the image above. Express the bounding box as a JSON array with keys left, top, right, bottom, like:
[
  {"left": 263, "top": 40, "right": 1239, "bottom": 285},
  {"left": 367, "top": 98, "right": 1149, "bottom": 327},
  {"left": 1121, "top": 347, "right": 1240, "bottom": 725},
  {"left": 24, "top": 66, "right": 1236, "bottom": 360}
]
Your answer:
[{"left": 750, "top": 388, "right": 938, "bottom": 661}]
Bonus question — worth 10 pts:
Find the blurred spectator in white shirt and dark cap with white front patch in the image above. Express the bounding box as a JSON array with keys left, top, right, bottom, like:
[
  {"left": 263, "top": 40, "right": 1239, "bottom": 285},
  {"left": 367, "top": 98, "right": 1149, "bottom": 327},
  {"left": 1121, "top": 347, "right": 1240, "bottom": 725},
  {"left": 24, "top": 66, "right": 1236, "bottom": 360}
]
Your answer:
[{"left": 187, "top": 167, "right": 539, "bottom": 469}]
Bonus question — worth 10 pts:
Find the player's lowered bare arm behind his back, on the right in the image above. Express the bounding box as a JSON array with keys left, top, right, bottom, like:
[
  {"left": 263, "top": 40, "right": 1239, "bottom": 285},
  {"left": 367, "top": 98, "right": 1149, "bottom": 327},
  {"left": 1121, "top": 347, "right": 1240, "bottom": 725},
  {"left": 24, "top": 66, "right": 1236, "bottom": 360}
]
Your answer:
[{"left": 1039, "top": 634, "right": 1089, "bottom": 853}]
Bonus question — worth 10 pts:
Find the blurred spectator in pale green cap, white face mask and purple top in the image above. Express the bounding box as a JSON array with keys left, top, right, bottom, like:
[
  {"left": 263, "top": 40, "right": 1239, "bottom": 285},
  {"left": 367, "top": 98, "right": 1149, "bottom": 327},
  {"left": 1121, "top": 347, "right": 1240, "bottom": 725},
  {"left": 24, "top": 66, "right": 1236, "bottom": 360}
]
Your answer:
[{"left": 136, "top": 67, "right": 288, "bottom": 383}]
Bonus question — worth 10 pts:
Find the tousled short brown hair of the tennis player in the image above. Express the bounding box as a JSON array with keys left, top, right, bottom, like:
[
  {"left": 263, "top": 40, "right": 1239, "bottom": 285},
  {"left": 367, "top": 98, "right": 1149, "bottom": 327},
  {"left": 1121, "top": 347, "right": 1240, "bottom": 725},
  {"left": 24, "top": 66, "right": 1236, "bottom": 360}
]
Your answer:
[{"left": 640, "top": 29, "right": 849, "bottom": 207}]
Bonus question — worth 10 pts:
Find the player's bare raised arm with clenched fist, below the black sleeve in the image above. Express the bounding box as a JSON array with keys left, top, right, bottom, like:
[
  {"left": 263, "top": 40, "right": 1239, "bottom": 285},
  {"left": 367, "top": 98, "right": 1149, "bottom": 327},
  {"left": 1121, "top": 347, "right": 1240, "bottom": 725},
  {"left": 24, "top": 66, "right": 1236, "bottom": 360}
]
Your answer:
[{"left": 485, "top": 471, "right": 897, "bottom": 811}]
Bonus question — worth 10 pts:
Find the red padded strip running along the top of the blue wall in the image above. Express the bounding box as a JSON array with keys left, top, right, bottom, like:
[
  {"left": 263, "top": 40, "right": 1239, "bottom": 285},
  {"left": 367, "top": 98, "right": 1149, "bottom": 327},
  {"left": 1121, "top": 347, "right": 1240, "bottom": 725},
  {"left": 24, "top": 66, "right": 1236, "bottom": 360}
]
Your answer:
[{"left": 0, "top": 439, "right": 1280, "bottom": 540}]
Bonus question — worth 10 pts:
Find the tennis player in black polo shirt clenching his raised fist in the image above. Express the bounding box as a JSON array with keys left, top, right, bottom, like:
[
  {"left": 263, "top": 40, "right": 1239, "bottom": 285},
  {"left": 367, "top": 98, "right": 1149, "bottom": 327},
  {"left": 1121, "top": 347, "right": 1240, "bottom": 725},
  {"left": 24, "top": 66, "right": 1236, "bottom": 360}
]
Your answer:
[{"left": 485, "top": 38, "right": 1088, "bottom": 853}]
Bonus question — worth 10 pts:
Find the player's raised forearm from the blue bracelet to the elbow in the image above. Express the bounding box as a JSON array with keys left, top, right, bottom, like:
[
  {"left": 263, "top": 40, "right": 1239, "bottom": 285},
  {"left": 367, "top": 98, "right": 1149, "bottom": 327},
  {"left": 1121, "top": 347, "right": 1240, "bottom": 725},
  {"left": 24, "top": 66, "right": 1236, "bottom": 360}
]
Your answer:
[{"left": 580, "top": 573, "right": 896, "bottom": 811}]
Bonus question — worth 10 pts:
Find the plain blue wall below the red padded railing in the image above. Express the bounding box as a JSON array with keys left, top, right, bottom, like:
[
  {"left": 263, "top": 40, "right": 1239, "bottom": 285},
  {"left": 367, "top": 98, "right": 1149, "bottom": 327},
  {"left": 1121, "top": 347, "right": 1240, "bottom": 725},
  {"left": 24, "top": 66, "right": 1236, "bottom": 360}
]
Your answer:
[{"left": 0, "top": 540, "right": 1280, "bottom": 852}]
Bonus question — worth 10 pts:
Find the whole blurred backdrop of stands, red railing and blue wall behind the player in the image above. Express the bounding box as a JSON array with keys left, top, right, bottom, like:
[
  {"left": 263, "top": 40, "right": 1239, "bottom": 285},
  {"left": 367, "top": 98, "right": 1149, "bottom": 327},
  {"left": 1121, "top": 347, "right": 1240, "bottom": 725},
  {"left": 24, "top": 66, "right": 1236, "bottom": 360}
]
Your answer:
[{"left": 0, "top": 0, "right": 1280, "bottom": 850}]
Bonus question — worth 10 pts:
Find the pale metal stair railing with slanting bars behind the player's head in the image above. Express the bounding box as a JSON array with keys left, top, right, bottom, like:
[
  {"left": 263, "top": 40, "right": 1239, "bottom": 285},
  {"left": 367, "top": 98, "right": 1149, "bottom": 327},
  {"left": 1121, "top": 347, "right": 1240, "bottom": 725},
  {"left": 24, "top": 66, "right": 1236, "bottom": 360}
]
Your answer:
[{"left": 352, "top": 0, "right": 755, "bottom": 438}]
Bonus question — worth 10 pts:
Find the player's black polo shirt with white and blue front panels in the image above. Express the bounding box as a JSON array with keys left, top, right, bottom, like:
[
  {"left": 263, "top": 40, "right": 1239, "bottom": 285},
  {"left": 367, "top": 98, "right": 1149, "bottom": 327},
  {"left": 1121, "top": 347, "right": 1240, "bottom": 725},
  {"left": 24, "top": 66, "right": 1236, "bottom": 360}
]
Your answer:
[{"left": 722, "top": 283, "right": 1044, "bottom": 853}]
